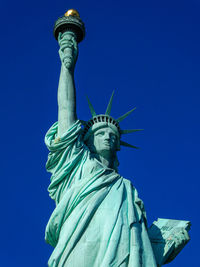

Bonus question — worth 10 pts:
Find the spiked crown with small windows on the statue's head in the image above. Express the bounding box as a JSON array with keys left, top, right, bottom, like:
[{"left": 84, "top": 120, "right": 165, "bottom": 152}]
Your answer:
[{"left": 81, "top": 91, "right": 143, "bottom": 149}]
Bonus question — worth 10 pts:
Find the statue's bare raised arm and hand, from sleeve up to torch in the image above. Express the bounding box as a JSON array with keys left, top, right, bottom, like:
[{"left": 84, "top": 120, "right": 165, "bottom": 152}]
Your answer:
[{"left": 58, "top": 32, "right": 78, "bottom": 137}]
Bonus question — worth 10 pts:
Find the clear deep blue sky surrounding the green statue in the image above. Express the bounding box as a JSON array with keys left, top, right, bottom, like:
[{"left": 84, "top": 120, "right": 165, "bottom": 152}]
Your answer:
[{"left": 0, "top": 0, "right": 200, "bottom": 267}]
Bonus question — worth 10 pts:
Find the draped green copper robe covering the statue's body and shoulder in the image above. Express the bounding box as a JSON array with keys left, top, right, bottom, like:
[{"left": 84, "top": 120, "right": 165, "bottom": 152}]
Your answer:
[{"left": 45, "top": 121, "right": 157, "bottom": 267}]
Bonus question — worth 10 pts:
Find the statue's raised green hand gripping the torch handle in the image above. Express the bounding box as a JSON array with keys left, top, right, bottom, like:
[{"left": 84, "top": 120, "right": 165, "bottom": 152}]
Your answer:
[{"left": 58, "top": 32, "right": 78, "bottom": 71}]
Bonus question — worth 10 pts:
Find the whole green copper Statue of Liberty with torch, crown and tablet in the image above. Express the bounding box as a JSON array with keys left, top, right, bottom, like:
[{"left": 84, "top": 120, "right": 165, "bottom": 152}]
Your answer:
[{"left": 45, "top": 10, "right": 189, "bottom": 267}]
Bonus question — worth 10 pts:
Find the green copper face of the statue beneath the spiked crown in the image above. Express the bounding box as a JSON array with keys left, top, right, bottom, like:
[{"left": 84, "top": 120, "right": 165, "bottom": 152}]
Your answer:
[{"left": 93, "top": 127, "right": 118, "bottom": 155}]
